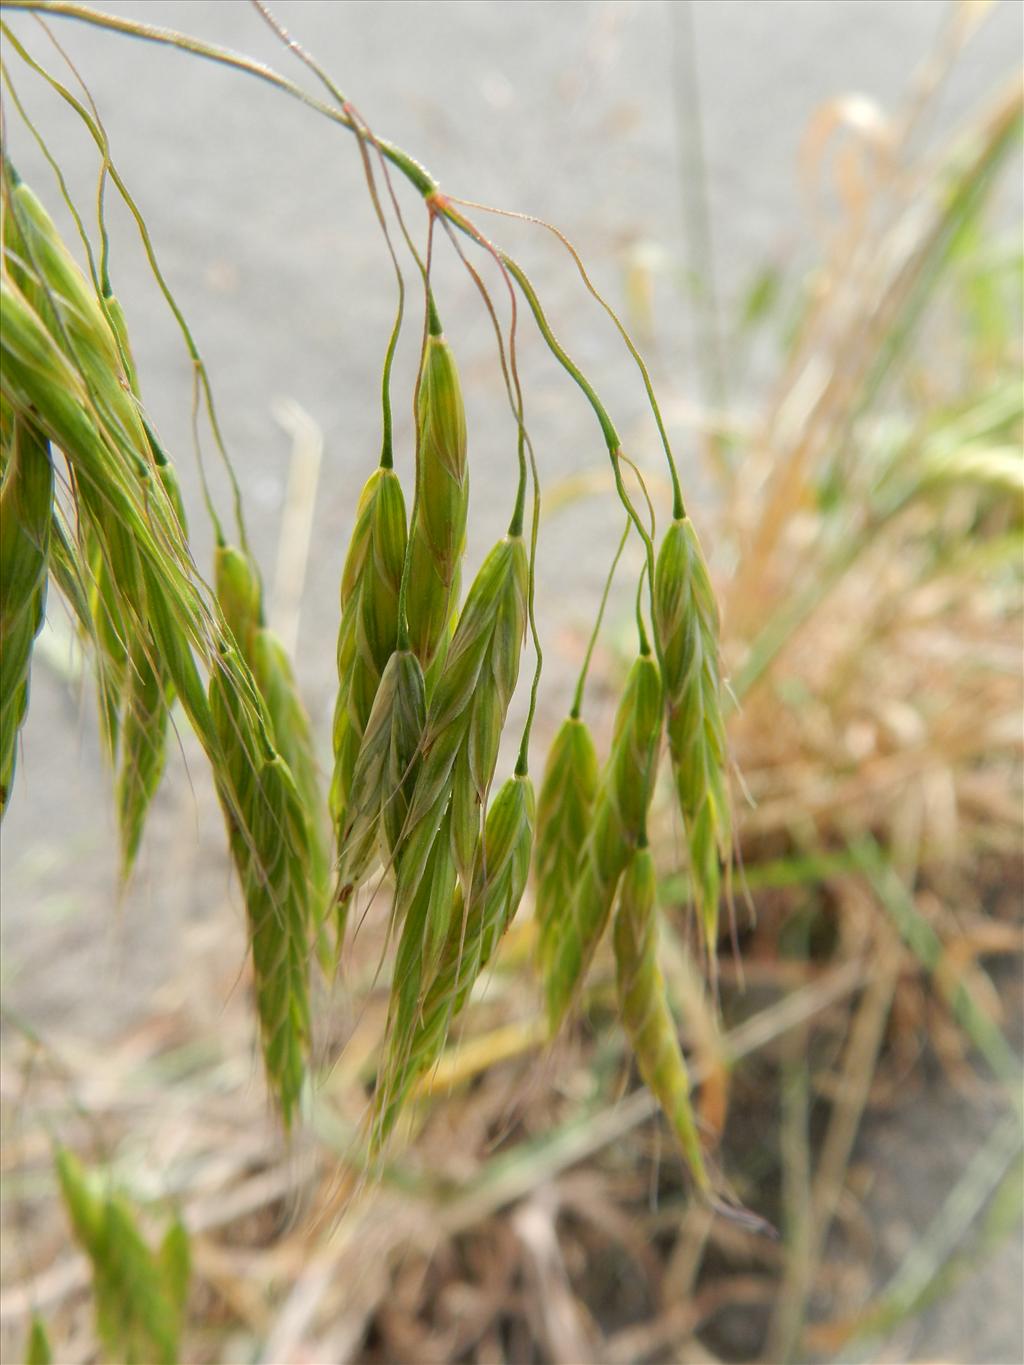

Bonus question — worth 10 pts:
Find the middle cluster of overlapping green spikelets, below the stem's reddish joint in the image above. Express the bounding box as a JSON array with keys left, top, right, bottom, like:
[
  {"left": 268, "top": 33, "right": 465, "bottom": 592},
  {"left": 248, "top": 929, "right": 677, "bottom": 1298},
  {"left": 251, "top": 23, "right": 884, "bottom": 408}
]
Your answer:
[{"left": 330, "top": 312, "right": 534, "bottom": 1148}]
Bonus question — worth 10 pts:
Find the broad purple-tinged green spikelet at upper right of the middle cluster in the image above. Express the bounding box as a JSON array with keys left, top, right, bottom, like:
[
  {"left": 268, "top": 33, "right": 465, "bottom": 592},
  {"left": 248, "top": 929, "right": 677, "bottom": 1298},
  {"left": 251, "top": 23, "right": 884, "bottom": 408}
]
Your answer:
[{"left": 395, "top": 536, "right": 528, "bottom": 966}]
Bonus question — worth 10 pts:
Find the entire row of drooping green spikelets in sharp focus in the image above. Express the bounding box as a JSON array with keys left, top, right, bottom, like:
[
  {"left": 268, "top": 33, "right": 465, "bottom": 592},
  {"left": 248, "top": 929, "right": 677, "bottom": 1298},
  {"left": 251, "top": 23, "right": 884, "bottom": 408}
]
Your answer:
[{"left": 0, "top": 156, "right": 730, "bottom": 1188}]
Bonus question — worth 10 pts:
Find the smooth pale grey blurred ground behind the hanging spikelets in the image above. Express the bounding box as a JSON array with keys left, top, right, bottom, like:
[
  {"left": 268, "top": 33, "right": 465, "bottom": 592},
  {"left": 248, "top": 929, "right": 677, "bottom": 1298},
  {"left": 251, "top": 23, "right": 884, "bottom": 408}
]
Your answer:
[{"left": 0, "top": 0, "right": 1024, "bottom": 1362}]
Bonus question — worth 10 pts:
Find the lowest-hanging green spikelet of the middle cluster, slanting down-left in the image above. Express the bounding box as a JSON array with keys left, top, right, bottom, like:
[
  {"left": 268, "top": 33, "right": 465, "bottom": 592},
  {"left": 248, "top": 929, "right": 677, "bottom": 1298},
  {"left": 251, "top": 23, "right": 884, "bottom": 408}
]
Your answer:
[{"left": 374, "top": 775, "right": 537, "bottom": 1148}]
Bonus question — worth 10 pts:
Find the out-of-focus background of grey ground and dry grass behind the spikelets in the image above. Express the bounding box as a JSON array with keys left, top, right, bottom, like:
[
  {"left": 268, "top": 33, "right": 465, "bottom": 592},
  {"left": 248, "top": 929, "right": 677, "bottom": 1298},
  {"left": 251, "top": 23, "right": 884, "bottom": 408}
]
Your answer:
[{"left": 0, "top": 0, "right": 1024, "bottom": 1365}]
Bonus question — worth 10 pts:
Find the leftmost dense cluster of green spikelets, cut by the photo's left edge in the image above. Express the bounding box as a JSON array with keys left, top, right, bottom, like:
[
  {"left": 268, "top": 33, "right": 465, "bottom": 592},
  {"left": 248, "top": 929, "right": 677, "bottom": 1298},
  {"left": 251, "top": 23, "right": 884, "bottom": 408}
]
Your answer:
[{"left": 0, "top": 164, "right": 320, "bottom": 1123}]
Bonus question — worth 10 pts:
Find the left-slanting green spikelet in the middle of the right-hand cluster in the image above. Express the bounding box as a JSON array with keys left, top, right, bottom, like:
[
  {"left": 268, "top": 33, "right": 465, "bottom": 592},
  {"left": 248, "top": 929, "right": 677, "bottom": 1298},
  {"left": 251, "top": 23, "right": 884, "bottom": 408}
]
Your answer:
[{"left": 545, "top": 654, "right": 662, "bottom": 1033}]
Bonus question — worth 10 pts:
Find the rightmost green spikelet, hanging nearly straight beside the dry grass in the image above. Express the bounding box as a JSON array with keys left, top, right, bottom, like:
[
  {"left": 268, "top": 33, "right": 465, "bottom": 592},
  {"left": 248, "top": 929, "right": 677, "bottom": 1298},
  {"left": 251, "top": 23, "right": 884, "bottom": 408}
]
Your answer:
[{"left": 654, "top": 519, "right": 732, "bottom": 954}]
